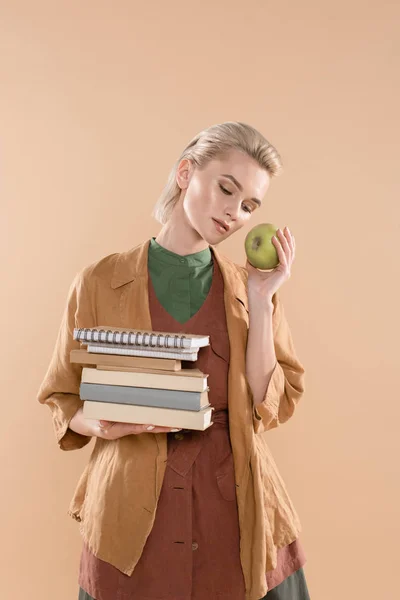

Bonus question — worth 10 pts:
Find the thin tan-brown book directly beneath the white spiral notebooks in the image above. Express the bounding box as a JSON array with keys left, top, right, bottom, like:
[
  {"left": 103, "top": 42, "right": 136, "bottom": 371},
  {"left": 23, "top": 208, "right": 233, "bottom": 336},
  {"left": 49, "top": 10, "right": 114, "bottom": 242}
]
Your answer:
[{"left": 70, "top": 348, "right": 182, "bottom": 371}]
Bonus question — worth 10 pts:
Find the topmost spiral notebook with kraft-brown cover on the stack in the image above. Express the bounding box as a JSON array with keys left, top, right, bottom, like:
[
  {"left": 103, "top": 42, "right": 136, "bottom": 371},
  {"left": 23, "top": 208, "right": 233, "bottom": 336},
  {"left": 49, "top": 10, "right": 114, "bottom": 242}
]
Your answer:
[{"left": 73, "top": 325, "right": 210, "bottom": 352}]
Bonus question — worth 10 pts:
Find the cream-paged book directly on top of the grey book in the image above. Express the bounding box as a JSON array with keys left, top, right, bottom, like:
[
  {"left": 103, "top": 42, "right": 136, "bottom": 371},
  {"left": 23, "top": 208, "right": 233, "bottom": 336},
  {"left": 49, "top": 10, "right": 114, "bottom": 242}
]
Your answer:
[{"left": 81, "top": 367, "right": 208, "bottom": 392}]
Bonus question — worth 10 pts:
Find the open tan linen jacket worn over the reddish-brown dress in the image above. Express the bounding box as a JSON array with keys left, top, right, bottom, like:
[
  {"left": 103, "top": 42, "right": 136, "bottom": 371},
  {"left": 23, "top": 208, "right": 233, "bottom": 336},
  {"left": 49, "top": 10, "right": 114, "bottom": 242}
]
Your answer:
[{"left": 38, "top": 240, "right": 304, "bottom": 600}]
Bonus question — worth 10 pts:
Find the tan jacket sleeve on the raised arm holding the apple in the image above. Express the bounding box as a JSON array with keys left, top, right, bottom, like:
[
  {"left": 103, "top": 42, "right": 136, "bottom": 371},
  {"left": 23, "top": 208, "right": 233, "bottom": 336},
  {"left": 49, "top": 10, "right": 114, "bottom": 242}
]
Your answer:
[{"left": 253, "top": 292, "right": 304, "bottom": 433}]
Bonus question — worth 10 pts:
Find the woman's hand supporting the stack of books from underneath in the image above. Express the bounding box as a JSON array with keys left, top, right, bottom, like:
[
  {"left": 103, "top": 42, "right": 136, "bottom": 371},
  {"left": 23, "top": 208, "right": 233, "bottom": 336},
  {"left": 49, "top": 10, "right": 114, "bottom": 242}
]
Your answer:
[{"left": 69, "top": 408, "right": 180, "bottom": 440}]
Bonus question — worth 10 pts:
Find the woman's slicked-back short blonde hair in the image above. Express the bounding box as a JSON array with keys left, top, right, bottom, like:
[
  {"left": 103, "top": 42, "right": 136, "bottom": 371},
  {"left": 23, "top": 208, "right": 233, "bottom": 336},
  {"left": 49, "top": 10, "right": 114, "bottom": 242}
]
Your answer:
[{"left": 152, "top": 121, "right": 283, "bottom": 225}]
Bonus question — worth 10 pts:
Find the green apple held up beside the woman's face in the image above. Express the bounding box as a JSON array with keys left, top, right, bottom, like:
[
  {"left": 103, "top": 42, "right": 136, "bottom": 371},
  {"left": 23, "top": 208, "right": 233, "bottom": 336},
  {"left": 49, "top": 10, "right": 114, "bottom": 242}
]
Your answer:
[{"left": 244, "top": 223, "right": 279, "bottom": 269}]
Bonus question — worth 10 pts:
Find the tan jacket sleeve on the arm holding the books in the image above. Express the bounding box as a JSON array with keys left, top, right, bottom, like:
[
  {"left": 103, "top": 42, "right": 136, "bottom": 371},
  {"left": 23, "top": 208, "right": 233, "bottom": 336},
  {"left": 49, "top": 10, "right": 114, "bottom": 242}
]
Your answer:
[{"left": 37, "top": 270, "right": 93, "bottom": 450}]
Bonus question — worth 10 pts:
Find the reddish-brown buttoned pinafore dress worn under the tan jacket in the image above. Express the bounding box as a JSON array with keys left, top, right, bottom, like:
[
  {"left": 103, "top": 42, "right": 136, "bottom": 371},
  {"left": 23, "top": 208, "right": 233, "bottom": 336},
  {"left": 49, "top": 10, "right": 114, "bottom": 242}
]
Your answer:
[{"left": 79, "top": 254, "right": 305, "bottom": 600}]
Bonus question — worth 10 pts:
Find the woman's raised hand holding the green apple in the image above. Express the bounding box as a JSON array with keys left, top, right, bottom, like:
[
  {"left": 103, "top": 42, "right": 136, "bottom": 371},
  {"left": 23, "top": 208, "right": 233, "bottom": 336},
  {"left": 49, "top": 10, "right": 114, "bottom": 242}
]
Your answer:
[{"left": 246, "top": 227, "right": 296, "bottom": 303}]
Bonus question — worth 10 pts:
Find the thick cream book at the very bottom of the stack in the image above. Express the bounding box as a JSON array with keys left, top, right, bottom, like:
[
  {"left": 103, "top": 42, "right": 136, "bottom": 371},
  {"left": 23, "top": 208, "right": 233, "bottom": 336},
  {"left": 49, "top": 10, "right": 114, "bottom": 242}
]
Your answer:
[{"left": 83, "top": 401, "right": 214, "bottom": 431}]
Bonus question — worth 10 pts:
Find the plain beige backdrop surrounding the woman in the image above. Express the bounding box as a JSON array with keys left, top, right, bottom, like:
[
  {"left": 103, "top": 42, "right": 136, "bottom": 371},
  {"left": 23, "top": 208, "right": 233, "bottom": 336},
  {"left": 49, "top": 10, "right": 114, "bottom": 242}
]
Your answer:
[{"left": 0, "top": 0, "right": 400, "bottom": 600}]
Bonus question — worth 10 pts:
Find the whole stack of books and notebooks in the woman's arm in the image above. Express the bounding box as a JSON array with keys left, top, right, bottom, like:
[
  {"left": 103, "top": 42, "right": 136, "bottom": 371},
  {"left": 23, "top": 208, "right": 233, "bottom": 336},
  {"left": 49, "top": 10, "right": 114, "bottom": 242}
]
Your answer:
[{"left": 70, "top": 326, "right": 213, "bottom": 431}]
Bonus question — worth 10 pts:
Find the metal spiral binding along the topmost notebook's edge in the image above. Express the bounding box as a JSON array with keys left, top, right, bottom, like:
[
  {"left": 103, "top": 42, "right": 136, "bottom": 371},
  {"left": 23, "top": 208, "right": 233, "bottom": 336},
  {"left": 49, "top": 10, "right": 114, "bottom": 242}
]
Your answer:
[{"left": 74, "top": 327, "right": 187, "bottom": 349}]
